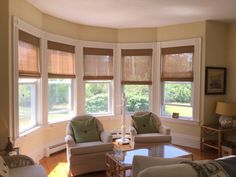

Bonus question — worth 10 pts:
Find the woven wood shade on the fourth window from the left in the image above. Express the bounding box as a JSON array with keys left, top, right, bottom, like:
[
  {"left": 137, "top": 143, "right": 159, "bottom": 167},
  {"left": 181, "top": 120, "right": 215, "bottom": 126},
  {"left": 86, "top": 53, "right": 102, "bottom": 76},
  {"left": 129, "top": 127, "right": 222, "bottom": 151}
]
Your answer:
[{"left": 121, "top": 49, "right": 152, "bottom": 85}]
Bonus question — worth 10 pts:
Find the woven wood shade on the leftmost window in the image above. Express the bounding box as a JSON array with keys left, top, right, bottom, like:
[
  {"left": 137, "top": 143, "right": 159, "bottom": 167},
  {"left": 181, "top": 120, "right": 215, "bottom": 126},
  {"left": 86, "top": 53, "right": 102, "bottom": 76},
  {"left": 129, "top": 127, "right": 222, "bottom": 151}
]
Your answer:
[{"left": 18, "top": 30, "right": 41, "bottom": 77}]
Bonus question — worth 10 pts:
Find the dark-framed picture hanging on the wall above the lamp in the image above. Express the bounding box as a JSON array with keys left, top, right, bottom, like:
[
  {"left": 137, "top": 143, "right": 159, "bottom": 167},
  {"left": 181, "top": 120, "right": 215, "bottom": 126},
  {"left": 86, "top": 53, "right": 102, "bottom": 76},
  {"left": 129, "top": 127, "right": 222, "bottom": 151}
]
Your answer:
[{"left": 205, "top": 67, "right": 227, "bottom": 95}]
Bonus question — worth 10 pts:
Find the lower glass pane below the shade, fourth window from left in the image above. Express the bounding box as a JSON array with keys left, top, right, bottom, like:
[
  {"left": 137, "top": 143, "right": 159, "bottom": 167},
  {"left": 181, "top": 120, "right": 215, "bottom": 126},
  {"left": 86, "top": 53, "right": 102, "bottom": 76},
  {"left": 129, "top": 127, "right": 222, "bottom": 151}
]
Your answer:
[{"left": 124, "top": 85, "right": 149, "bottom": 112}]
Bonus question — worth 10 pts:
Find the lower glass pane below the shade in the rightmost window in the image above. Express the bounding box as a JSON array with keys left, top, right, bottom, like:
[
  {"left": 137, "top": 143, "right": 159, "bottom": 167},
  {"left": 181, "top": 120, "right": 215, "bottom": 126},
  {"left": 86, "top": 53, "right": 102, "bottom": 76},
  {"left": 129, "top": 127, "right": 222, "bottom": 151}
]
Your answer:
[{"left": 163, "top": 82, "right": 192, "bottom": 117}]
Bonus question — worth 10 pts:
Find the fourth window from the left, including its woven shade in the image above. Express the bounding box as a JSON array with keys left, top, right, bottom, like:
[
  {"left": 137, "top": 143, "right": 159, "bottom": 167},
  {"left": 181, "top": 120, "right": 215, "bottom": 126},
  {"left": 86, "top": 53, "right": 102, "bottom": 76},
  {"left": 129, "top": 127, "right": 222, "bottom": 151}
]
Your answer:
[{"left": 121, "top": 49, "right": 152, "bottom": 112}]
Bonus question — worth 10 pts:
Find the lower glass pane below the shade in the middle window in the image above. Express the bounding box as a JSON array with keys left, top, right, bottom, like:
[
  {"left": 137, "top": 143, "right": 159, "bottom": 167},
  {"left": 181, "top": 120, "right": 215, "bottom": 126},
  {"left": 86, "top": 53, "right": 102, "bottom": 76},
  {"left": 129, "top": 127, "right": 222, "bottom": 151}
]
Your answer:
[{"left": 85, "top": 82, "right": 110, "bottom": 114}]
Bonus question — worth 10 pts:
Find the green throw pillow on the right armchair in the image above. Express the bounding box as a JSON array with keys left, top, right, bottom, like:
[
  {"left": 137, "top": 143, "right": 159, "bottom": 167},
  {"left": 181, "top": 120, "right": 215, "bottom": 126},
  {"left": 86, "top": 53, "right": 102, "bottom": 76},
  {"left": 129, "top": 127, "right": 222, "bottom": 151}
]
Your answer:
[{"left": 131, "top": 113, "right": 157, "bottom": 134}]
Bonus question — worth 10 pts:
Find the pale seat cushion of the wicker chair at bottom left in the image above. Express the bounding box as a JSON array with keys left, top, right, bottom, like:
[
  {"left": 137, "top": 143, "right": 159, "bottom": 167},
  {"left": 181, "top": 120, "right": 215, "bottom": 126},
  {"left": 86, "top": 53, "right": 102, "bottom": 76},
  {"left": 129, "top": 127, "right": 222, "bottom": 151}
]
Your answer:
[{"left": 10, "top": 165, "right": 46, "bottom": 177}]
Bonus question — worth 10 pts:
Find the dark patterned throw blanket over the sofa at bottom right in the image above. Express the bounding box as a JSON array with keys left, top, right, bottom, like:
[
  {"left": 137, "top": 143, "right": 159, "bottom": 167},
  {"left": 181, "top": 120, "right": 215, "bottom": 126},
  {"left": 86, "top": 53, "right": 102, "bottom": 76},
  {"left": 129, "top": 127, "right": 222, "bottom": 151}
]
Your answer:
[{"left": 182, "top": 157, "right": 236, "bottom": 177}]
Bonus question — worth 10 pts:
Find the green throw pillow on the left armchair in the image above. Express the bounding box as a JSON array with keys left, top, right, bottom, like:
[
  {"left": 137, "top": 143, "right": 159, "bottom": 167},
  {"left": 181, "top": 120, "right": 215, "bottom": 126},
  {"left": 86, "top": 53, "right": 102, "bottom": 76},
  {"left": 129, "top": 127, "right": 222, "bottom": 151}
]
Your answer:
[{"left": 71, "top": 118, "right": 100, "bottom": 143}]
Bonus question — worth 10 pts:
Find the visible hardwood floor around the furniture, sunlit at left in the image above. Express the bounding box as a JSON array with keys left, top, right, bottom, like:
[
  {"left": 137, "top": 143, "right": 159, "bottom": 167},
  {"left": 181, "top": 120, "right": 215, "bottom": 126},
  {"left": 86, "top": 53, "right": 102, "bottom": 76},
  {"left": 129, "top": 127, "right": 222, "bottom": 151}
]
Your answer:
[{"left": 40, "top": 146, "right": 217, "bottom": 177}]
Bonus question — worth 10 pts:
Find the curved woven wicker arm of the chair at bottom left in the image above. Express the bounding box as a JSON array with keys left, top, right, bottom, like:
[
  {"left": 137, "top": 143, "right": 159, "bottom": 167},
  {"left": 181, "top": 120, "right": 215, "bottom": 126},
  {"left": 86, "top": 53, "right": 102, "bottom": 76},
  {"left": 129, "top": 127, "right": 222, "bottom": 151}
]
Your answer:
[{"left": 4, "top": 155, "right": 34, "bottom": 168}]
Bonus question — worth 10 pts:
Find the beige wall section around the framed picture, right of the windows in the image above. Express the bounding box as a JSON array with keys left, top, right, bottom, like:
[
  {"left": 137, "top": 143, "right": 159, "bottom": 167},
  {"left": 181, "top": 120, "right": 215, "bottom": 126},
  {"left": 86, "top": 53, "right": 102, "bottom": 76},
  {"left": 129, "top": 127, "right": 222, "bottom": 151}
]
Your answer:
[{"left": 203, "top": 21, "right": 228, "bottom": 124}]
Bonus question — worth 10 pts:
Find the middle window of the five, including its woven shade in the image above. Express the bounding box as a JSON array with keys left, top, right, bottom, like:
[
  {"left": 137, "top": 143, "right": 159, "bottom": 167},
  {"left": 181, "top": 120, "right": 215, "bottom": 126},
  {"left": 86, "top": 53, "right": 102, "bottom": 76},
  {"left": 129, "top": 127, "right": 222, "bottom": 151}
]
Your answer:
[{"left": 83, "top": 47, "right": 113, "bottom": 114}]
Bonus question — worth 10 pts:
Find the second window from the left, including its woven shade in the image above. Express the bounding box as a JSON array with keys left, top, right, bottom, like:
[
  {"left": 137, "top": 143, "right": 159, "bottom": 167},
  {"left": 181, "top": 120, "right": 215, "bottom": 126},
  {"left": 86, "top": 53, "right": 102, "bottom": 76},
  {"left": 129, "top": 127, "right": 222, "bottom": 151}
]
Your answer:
[{"left": 48, "top": 41, "right": 75, "bottom": 122}]
